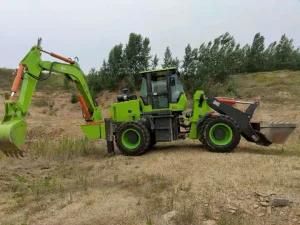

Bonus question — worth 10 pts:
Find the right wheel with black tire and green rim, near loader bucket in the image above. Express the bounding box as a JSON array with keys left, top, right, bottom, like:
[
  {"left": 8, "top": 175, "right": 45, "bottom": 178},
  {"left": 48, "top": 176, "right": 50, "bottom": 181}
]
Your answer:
[{"left": 203, "top": 115, "right": 241, "bottom": 153}]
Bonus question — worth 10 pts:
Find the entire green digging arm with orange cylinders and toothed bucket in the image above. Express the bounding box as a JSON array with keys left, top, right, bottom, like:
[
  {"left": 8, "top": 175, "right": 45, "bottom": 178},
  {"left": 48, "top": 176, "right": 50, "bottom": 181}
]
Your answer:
[{"left": 0, "top": 46, "right": 105, "bottom": 155}]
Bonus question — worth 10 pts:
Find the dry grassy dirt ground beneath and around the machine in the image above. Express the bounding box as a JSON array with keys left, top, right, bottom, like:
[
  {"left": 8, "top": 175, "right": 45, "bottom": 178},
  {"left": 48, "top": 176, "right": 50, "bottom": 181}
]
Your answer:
[{"left": 0, "top": 72, "right": 300, "bottom": 225}]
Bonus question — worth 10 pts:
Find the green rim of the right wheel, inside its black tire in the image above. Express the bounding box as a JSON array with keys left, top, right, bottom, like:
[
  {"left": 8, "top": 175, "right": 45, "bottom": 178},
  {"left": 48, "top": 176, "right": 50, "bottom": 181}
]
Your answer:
[{"left": 209, "top": 123, "right": 233, "bottom": 146}]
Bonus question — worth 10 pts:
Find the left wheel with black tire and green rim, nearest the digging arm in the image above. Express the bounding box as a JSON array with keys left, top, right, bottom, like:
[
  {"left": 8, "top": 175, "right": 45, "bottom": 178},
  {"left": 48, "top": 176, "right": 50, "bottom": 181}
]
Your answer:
[{"left": 116, "top": 122, "right": 150, "bottom": 156}]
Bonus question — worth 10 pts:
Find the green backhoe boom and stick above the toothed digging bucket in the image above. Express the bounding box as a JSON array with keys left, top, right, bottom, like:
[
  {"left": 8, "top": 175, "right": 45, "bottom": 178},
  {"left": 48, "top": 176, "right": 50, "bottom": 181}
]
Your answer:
[{"left": 12, "top": 47, "right": 102, "bottom": 121}]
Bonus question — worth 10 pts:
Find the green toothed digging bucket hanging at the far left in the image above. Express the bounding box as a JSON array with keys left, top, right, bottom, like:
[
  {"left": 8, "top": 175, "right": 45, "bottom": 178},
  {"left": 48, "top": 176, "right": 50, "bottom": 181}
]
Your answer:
[{"left": 0, "top": 119, "right": 26, "bottom": 157}]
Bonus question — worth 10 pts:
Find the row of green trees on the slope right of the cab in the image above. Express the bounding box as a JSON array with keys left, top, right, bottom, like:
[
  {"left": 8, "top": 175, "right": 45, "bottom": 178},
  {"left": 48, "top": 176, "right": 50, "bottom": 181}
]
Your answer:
[{"left": 181, "top": 33, "right": 300, "bottom": 95}]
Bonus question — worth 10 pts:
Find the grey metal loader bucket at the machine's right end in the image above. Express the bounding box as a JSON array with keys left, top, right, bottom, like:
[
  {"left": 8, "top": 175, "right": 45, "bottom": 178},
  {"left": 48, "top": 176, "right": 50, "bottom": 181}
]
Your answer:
[{"left": 260, "top": 123, "right": 296, "bottom": 144}]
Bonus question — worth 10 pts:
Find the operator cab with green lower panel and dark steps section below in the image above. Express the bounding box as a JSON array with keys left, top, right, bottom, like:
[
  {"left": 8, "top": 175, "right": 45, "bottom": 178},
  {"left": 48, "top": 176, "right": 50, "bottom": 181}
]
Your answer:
[{"left": 140, "top": 68, "right": 187, "bottom": 142}]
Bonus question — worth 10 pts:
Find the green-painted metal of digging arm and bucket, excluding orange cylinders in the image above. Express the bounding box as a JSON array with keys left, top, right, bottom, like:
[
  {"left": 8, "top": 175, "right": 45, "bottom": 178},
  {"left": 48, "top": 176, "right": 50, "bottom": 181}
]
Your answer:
[{"left": 0, "top": 46, "right": 105, "bottom": 153}]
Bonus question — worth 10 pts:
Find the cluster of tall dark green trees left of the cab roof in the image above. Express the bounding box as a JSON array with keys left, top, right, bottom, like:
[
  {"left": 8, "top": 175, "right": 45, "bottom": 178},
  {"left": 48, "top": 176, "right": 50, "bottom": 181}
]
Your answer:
[{"left": 88, "top": 33, "right": 152, "bottom": 93}]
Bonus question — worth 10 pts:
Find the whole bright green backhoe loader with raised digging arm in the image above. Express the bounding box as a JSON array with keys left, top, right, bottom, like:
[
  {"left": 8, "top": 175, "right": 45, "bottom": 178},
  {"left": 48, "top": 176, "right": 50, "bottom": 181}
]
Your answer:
[{"left": 0, "top": 40, "right": 296, "bottom": 156}]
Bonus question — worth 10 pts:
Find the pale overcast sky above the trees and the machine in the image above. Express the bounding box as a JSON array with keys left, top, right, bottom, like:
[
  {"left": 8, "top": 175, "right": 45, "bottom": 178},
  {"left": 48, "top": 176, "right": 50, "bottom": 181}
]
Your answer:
[{"left": 0, "top": 0, "right": 300, "bottom": 73}]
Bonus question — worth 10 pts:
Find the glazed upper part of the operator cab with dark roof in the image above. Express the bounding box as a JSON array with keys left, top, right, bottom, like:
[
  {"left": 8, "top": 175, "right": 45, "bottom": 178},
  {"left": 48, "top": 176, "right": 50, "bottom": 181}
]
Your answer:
[{"left": 140, "top": 67, "right": 185, "bottom": 110}]
